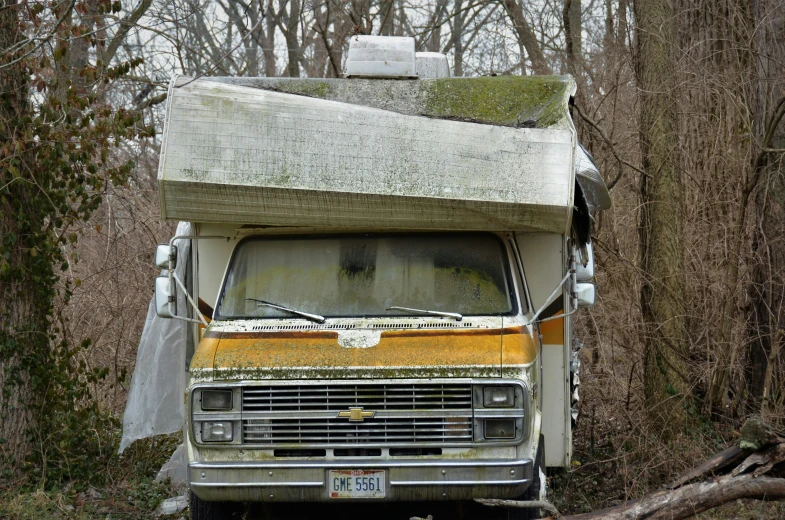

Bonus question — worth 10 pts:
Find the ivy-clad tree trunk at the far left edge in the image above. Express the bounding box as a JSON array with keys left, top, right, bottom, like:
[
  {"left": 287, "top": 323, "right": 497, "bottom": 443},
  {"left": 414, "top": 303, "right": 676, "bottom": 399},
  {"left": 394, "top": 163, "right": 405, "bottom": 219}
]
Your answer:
[{"left": 0, "top": 0, "right": 40, "bottom": 469}]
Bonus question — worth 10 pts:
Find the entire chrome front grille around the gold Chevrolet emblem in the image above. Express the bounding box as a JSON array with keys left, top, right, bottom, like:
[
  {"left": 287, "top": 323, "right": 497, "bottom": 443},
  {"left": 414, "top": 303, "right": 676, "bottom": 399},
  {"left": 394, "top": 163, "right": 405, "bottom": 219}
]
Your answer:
[{"left": 242, "top": 383, "right": 473, "bottom": 446}]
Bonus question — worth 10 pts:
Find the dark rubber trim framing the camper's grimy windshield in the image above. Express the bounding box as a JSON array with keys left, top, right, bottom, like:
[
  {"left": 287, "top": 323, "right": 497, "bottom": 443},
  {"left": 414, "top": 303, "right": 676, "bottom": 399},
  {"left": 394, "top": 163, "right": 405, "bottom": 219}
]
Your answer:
[{"left": 213, "top": 231, "right": 521, "bottom": 321}]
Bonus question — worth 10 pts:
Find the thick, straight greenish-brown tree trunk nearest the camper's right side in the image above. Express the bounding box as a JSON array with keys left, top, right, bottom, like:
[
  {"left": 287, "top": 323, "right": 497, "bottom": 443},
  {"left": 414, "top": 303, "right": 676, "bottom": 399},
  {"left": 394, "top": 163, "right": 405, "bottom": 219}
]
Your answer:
[{"left": 635, "top": 0, "right": 689, "bottom": 433}]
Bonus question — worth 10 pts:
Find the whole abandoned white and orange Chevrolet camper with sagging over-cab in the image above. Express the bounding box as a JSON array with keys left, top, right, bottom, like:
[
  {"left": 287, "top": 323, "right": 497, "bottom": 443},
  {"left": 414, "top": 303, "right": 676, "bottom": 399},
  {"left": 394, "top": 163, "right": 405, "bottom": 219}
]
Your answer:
[{"left": 155, "top": 36, "right": 610, "bottom": 519}]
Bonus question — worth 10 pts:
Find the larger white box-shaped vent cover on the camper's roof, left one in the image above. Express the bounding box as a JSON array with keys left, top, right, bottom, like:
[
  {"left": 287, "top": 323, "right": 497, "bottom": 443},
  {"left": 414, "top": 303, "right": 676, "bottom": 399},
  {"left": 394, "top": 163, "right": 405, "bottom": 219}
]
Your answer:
[{"left": 345, "top": 35, "right": 417, "bottom": 78}]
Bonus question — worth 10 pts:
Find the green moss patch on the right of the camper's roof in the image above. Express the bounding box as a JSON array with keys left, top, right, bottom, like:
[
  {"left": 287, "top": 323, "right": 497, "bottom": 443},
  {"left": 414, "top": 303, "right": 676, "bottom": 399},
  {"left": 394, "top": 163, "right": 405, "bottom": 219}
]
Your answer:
[{"left": 421, "top": 76, "right": 574, "bottom": 128}]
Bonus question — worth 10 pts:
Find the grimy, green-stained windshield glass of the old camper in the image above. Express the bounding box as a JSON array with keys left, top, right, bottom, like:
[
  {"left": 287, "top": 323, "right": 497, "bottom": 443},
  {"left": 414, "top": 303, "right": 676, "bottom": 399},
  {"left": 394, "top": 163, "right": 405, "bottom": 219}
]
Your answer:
[{"left": 216, "top": 233, "right": 513, "bottom": 319}]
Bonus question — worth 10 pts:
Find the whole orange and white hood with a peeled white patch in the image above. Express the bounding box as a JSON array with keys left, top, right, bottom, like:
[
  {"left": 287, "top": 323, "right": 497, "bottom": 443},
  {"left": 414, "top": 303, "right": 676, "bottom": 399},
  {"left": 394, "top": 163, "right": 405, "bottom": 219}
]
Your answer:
[{"left": 191, "top": 326, "right": 537, "bottom": 380}]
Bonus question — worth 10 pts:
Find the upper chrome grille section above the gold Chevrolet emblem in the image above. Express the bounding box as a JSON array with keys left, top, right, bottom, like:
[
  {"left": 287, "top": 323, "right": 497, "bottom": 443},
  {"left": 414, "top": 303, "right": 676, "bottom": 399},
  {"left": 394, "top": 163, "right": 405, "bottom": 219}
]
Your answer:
[{"left": 243, "top": 383, "right": 472, "bottom": 412}]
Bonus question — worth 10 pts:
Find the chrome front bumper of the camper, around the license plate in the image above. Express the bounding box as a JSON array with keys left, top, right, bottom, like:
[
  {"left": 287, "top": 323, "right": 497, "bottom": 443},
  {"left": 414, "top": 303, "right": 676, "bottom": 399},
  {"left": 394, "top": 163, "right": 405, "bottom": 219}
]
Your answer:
[{"left": 188, "top": 459, "right": 533, "bottom": 502}]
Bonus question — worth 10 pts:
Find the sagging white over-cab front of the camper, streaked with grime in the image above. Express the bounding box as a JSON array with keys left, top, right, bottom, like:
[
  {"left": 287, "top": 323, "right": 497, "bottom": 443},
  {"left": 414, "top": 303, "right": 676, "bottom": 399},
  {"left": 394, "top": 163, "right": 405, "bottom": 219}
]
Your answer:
[{"left": 158, "top": 77, "right": 576, "bottom": 233}]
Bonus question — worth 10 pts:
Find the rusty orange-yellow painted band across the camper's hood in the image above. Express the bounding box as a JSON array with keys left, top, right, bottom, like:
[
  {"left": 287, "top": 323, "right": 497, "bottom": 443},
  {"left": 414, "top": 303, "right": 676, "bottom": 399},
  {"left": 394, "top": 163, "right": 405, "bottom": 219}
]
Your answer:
[{"left": 191, "top": 327, "right": 537, "bottom": 369}]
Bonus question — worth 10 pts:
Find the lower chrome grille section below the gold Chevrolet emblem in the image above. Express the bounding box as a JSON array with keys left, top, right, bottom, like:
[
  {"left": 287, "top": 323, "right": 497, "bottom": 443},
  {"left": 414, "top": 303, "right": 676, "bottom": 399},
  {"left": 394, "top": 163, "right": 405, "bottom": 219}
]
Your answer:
[{"left": 243, "top": 416, "right": 472, "bottom": 444}]
